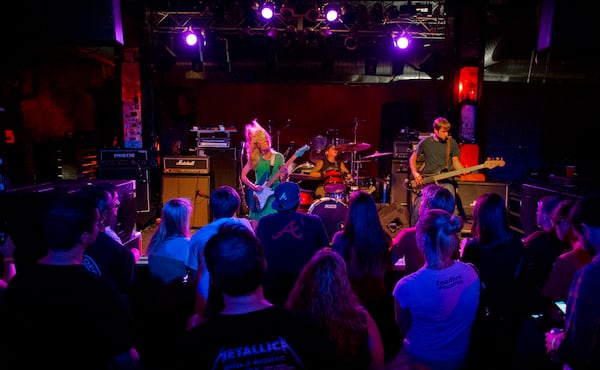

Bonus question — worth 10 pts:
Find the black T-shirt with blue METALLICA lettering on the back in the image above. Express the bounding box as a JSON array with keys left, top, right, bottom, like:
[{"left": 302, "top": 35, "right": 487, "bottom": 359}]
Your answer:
[{"left": 173, "top": 306, "right": 338, "bottom": 370}]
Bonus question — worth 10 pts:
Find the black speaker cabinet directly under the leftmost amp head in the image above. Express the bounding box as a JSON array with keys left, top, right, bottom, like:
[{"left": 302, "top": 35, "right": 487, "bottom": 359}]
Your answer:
[{"left": 98, "top": 166, "right": 150, "bottom": 213}]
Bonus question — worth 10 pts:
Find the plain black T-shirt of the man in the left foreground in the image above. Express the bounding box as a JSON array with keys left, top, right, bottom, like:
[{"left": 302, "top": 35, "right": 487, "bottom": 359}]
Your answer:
[{"left": 0, "top": 263, "right": 136, "bottom": 369}]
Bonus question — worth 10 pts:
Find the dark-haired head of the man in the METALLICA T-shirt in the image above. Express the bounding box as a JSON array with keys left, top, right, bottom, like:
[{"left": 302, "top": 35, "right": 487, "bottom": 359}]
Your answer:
[{"left": 204, "top": 224, "right": 266, "bottom": 297}]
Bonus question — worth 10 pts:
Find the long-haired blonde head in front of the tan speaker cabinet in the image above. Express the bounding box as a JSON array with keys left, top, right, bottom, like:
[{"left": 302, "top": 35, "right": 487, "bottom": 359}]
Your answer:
[{"left": 148, "top": 198, "right": 193, "bottom": 252}]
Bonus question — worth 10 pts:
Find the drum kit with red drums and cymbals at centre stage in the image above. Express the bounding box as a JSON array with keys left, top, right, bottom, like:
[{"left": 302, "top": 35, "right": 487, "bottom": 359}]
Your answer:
[{"left": 288, "top": 122, "right": 392, "bottom": 239}]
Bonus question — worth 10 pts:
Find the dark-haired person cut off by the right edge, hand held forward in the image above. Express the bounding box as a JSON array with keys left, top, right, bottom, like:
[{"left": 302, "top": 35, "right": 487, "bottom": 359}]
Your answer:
[{"left": 546, "top": 193, "right": 600, "bottom": 370}]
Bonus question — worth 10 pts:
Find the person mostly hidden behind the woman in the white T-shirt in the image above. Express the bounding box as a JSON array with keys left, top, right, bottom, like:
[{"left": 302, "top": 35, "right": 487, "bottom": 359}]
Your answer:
[{"left": 390, "top": 184, "right": 456, "bottom": 274}]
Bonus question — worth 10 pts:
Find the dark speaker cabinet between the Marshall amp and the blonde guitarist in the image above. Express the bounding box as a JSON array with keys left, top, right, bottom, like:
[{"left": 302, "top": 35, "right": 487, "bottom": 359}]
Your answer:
[{"left": 203, "top": 148, "right": 240, "bottom": 189}]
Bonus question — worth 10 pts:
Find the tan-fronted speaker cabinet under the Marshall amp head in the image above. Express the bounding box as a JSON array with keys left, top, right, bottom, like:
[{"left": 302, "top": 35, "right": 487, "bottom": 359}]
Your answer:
[{"left": 162, "top": 175, "right": 210, "bottom": 228}]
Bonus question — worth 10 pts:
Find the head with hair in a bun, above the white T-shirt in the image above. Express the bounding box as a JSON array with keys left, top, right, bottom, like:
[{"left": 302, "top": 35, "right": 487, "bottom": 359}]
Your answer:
[{"left": 416, "top": 209, "right": 463, "bottom": 268}]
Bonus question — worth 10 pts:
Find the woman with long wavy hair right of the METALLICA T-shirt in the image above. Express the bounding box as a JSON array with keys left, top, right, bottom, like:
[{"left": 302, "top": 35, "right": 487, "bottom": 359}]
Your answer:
[{"left": 286, "top": 248, "right": 384, "bottom": 369}]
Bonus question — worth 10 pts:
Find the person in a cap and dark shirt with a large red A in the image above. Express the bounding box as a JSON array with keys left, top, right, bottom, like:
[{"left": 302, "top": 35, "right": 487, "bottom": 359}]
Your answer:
[{"left": 256, "top": 182, "right": 329, "bottom": 306}]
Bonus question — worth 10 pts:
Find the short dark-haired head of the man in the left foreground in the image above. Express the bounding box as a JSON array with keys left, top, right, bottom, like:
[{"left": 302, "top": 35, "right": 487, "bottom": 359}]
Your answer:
[{"left": 43, "top": 192, "right": 99, "bottom": 251}]
